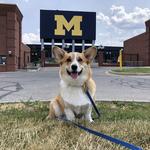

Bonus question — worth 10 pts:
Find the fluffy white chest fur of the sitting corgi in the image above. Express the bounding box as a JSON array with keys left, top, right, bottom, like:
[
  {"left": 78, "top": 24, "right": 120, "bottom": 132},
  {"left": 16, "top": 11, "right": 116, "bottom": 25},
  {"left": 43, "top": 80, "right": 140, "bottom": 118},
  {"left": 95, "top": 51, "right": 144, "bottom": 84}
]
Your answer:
[{"left": 60, "top": 83, "right": 90, "bottom": 106}]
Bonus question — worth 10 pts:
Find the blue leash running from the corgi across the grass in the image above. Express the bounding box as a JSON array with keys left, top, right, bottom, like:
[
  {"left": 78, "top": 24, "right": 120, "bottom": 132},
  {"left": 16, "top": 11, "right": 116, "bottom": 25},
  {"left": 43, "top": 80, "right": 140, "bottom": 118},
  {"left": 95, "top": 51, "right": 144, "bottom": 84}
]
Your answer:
[{"left": 63, "top": 90, "right": 142, "bottom": 150}]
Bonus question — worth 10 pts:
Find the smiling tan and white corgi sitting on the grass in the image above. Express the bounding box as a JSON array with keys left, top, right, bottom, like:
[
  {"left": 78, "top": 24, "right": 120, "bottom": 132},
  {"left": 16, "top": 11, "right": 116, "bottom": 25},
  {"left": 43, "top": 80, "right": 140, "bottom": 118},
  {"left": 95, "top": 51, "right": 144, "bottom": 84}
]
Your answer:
[{"left": 48, "top": 46, "right": 97, "bottom": 122}]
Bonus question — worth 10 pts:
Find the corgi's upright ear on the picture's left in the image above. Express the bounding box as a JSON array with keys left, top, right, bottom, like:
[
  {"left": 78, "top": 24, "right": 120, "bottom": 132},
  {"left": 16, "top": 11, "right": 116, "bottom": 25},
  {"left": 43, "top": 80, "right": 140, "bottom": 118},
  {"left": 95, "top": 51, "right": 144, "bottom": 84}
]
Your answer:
[{"left": 52, "top": 46, "right": 66, "bottom": 63}]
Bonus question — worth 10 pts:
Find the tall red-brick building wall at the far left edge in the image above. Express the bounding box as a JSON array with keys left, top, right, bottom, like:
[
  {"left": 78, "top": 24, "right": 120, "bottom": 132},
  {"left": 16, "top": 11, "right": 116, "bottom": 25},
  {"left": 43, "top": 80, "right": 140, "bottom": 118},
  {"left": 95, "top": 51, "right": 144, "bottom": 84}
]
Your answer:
[{"left": 0, "top": 4, "right": 22, "bottom": 71}]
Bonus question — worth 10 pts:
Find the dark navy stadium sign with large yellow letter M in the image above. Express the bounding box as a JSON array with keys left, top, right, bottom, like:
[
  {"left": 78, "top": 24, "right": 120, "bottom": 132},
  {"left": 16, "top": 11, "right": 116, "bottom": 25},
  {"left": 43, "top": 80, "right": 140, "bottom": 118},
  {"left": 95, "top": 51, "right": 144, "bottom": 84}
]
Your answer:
[{"left": 40, "top": 10, "right": 96, "bottom": 43}]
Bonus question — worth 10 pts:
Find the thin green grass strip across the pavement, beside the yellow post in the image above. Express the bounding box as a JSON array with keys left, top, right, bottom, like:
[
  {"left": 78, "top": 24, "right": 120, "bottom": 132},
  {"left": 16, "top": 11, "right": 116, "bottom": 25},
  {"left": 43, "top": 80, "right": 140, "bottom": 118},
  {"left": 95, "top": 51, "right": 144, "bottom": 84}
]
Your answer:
[{"left": 112, "top": 67, "right": 150, "bottom": 74}]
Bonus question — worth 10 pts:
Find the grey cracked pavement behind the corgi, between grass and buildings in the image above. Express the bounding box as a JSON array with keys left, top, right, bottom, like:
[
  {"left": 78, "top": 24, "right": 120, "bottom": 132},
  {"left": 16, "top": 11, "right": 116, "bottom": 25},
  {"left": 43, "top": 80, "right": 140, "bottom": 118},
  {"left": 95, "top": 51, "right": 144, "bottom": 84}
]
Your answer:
[{"left": 0, "top": 67, "right": 150, "bottom": 103}]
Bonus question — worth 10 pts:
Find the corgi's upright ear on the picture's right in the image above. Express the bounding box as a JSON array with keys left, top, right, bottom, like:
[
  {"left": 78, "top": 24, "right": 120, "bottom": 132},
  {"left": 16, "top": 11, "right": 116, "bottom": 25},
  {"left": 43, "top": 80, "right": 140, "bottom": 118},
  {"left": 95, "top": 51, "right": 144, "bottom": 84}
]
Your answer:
[{"left": 83, "top": 46, "right": 97, "bottom": 63}]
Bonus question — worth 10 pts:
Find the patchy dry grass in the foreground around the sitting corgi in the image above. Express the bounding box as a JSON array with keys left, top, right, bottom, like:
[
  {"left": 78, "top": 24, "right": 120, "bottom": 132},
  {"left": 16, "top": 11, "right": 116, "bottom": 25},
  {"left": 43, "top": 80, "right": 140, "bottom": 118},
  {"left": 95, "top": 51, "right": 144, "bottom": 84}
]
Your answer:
[{"left": 0, "top": 102, "right": 150, "bottom": 150}]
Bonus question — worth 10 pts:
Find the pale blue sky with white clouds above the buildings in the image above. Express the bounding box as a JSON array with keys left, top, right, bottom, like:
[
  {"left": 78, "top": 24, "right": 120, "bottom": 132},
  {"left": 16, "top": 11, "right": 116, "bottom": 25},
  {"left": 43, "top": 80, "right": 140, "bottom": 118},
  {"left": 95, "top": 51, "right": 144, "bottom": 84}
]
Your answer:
[{"left": 0, "top": 0, "right": 150, "bottom": 46}]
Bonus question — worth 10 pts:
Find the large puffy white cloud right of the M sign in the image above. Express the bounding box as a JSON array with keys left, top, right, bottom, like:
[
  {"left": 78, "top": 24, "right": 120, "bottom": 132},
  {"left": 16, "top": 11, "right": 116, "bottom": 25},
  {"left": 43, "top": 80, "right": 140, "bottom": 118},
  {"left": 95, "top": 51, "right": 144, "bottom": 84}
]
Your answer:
[{"left": 97, "top": 5, "right": 150, "bottom": 30}]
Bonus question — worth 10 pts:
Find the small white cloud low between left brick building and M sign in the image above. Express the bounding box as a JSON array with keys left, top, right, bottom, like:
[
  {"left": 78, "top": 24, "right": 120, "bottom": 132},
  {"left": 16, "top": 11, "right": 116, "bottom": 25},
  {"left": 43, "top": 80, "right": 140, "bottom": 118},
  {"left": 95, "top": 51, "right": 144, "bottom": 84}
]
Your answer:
[{"left": 22, "top": 33, "right": 40, "bottom": 44}]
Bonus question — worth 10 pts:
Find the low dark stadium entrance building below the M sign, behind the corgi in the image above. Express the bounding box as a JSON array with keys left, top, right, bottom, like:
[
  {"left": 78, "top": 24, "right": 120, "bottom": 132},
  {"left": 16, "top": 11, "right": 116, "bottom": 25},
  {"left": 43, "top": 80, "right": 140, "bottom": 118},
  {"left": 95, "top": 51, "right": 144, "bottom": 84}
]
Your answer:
[{"left": 28, "top": 44, "right": 123, "bottom": 66}]
